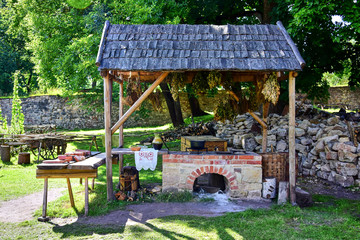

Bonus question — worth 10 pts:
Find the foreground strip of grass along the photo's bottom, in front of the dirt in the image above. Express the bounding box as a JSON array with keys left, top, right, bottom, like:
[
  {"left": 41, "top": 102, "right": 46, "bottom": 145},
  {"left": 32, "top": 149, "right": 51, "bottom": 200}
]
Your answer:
[{"left": 0, "top": 196, "right": 360, "bottom": 240}]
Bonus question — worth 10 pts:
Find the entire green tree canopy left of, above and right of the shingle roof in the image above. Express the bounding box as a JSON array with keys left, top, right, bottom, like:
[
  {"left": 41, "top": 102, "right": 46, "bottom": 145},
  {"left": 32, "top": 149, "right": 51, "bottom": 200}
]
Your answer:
[{"left": 0, "top": 0, "right": 360, "bottom": 104}]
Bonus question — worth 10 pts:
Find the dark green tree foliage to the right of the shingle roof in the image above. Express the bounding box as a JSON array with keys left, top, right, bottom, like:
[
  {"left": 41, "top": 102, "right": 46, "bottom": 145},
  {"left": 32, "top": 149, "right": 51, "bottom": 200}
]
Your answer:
[{"left": 272, "top": 0, "right": 360, "bottom": 100}]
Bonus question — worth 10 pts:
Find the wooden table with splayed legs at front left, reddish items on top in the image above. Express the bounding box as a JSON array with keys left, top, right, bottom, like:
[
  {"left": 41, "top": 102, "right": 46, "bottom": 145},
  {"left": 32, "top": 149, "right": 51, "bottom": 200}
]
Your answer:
[{"left": 36, "top": 152, "right": 106, "bottom": 222}]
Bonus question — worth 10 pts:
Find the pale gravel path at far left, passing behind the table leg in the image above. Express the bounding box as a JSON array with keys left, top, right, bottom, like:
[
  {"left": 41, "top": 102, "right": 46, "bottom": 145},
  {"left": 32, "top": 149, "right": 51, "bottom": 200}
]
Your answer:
[{"left": 0, "top": 188, "right": 66, "bottom": 223}]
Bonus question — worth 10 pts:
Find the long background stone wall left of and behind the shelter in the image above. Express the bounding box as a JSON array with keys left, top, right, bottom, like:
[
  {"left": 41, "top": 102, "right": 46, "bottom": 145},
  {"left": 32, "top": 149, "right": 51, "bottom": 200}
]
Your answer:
[{"left": 0, "top": 94, "right": 221, "bottom": 129}]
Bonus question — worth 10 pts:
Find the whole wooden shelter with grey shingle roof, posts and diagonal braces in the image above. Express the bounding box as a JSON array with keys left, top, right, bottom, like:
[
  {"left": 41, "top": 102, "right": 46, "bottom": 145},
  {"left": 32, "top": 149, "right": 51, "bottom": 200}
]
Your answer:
[{"left": 96, "top": 21, "right": 305, "bottom": 203}]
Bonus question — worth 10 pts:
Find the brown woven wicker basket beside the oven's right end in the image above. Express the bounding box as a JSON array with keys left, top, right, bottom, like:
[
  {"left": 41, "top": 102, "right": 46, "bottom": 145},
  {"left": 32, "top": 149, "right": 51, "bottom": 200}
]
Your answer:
[{"left": 259, "top": 152, "right": 298, "bottom": 182}]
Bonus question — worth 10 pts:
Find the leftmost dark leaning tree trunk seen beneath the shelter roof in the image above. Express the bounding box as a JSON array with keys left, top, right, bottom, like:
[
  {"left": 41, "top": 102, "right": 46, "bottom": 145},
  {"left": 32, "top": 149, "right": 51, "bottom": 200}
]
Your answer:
[{"left": 160, "top": 82, "right": 184, "bottom": 127}]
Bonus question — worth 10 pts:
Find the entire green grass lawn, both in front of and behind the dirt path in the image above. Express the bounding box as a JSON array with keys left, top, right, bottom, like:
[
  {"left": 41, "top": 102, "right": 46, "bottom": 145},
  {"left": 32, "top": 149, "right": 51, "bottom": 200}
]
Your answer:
[{"left": 0, "top": 119, "right": 360, "bottom": 240}]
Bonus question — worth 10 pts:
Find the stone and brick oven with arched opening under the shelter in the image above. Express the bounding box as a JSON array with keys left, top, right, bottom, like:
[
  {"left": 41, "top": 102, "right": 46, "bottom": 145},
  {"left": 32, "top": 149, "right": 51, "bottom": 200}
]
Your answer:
[{"left": 162, "top": 152, "right": 262, "bottom": 199}]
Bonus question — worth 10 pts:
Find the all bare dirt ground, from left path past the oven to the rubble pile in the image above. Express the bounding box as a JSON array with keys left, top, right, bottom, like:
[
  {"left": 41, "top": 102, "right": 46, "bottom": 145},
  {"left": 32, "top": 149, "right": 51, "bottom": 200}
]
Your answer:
[{"left": 0, "top": 177, "right": 360, "bottom": 225}]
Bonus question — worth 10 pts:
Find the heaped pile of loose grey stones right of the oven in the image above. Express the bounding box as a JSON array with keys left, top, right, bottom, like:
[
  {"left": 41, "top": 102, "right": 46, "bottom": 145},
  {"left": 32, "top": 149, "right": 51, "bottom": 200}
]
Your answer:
[{"left": 215, "top": 108, "right": 360, "bottom": 187}]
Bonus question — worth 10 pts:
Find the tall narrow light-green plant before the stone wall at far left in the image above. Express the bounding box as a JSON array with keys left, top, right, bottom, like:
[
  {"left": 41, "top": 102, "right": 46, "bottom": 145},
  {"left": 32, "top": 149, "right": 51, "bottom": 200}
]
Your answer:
[{"left": 9, "top": 71, "right": 25, "bottom": 134}]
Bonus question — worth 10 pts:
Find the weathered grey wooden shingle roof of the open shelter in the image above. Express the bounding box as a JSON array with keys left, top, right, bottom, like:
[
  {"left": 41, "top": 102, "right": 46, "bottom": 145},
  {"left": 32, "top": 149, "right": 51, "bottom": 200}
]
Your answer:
[{"left": 96, "top": 21, "right": 305, "bottom": 72}]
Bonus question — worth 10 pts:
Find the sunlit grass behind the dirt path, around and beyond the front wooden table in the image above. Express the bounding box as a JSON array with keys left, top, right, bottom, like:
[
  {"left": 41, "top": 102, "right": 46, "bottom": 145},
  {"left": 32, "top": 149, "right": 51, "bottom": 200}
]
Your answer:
[{"left": 0, "top": 125, "right": 180, "bottom": 214}]
